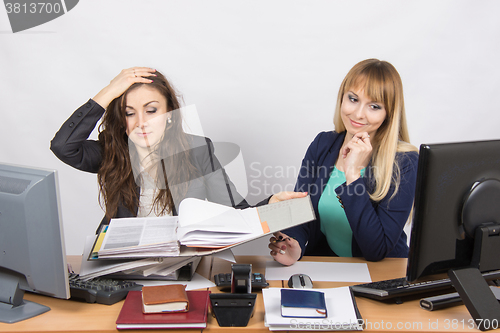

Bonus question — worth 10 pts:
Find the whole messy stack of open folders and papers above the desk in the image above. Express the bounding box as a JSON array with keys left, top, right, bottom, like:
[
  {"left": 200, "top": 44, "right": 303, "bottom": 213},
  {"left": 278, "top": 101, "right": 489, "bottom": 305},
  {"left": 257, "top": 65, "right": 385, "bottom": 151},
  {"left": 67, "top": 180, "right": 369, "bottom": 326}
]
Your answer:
[{"left": 80, "top": 196, "right": 315, "bottom": 280}]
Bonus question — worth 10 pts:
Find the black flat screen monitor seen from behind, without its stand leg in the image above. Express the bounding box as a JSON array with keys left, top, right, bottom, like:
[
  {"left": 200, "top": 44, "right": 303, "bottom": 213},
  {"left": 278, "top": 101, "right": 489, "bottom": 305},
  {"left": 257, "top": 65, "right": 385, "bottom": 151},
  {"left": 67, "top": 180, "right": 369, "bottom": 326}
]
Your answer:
[{"left": 407, "top": 140, "right": 500, "bottom": 281}]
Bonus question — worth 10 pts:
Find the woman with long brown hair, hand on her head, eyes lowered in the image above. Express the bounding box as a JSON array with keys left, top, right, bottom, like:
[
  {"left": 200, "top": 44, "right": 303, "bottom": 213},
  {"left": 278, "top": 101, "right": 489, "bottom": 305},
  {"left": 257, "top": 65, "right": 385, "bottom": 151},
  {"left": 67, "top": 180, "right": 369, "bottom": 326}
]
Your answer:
[{"left": 51, "top": 67, "right": 248, "bottom": 228}]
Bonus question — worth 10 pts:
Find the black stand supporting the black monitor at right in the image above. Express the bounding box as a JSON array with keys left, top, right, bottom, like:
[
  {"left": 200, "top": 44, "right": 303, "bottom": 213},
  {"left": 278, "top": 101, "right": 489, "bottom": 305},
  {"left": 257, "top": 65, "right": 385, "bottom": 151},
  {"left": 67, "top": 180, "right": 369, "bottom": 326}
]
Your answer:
[{"left": 448, "top": 224, "right": 500, "bottom": 331}]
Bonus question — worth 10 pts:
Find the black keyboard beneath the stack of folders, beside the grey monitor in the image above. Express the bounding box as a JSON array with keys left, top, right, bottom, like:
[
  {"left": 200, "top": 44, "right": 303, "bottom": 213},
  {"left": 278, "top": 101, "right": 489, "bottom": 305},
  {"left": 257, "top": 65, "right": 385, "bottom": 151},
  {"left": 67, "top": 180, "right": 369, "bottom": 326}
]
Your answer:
[{"left": 69, "top": 273, "right": 142, "bottom": 305}]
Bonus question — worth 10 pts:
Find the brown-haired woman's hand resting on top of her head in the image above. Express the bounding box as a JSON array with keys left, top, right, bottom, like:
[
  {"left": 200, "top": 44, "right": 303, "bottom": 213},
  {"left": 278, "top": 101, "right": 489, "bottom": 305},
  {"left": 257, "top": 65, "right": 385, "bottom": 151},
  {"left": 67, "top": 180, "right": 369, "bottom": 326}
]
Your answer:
[{"left": 93, "top": 67, "right": 156, "bottom": 109}]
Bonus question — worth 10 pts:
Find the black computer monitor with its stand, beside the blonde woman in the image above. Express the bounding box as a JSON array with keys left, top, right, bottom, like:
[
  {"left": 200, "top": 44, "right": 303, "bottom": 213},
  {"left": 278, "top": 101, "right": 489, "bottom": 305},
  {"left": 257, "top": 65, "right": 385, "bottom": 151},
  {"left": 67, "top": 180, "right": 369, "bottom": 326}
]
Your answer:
[{"left": 407, "top": 140, "right": 500, "bottom": 329}]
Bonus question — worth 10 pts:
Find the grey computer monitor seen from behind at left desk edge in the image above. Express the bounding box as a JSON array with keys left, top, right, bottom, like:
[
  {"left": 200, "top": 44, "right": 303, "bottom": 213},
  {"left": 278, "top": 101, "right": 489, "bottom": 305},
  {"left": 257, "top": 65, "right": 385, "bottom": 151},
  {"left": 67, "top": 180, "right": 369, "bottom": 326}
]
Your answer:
[{"left": 0, "top": 163, "right": 70, "bottom": 323}]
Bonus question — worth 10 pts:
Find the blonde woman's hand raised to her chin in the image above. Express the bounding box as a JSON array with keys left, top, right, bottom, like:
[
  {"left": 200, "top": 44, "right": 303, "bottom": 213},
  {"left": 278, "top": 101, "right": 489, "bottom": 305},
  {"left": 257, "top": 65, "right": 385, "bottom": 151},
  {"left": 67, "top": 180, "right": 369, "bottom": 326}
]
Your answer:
[{"left": 340, "top": 132, "right": 372, "bottom": 185}]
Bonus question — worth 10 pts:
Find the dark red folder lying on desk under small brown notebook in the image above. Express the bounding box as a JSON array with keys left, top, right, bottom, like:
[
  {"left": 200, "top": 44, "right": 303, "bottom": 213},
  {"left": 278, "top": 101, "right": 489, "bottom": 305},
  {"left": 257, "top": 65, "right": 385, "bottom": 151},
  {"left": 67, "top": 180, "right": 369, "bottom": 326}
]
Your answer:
[{"left": 116, "top": 290, "right": 210, "bottom": 329}]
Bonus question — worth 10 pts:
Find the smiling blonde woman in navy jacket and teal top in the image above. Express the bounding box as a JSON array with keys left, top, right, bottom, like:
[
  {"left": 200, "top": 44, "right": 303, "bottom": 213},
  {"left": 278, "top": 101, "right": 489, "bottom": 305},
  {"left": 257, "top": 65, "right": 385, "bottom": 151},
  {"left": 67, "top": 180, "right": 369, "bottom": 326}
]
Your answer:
[{"left": 269, "top": 59, "right": 418, "bottom": 265}]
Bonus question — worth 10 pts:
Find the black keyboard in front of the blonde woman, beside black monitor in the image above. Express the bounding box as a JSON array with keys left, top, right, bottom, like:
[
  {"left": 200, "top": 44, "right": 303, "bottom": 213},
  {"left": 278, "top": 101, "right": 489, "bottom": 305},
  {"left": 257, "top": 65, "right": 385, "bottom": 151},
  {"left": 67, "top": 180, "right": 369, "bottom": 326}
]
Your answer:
[{"left": 351, "top": 271, "right": 500, "bottom": 302}]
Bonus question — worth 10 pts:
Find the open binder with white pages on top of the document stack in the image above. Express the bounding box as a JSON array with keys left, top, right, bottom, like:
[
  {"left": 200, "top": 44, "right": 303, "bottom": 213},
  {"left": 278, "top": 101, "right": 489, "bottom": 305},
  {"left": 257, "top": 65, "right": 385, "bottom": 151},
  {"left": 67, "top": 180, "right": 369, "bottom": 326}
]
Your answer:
[{"left": 88, "top": 196, "right": 316, "bottom": 260}]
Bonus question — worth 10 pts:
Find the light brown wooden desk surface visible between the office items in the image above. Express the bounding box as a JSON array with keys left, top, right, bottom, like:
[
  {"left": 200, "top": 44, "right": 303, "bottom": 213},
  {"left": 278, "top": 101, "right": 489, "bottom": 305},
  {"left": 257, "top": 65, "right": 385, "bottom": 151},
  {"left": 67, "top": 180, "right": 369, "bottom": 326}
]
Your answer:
[{"left": 0, "top": 256, "right": 492, "bottom": 333}]
